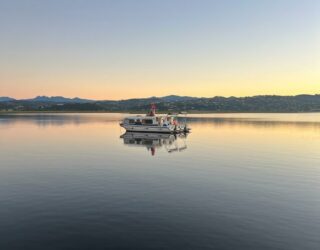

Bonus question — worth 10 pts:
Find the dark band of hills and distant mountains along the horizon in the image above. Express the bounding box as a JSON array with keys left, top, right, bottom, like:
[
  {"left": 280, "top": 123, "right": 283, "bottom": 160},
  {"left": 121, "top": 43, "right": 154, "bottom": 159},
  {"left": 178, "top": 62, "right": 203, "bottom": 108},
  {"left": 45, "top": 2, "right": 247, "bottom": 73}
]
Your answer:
[{"left": 0, "top": 95, "right": 320, "bottom": 112}]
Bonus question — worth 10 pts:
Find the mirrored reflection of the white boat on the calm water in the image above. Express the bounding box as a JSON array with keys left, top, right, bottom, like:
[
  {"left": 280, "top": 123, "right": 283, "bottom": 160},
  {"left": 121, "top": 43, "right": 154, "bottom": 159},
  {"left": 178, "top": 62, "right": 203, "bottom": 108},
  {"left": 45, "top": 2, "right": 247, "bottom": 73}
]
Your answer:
[{"left": 120, "top": 132, "right": 187, "bottom": 155}]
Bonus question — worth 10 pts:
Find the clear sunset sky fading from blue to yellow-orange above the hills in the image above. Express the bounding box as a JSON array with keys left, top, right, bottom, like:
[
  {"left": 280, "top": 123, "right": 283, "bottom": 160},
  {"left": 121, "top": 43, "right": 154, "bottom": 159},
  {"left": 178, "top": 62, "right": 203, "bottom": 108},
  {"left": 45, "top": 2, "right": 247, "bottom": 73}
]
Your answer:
[{"left": 0, "top": 0, "right": 320, "bottom": 99}]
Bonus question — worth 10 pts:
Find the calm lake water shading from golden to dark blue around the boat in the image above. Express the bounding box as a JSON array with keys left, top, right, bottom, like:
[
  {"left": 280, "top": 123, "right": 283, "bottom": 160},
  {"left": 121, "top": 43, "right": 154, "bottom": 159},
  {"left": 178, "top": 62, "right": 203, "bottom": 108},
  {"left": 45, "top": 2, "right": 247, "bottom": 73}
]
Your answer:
[{"left": 0, "top": 114, "right": 320, "bottom": 250}]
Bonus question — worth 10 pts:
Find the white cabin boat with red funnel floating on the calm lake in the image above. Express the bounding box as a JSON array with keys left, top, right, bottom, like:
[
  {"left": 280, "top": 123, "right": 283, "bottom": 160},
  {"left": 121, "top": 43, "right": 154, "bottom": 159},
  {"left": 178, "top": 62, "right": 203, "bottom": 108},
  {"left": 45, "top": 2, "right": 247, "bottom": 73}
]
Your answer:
[{"left": 120, "top": 104, "right": 190, "bottom": 134}]
